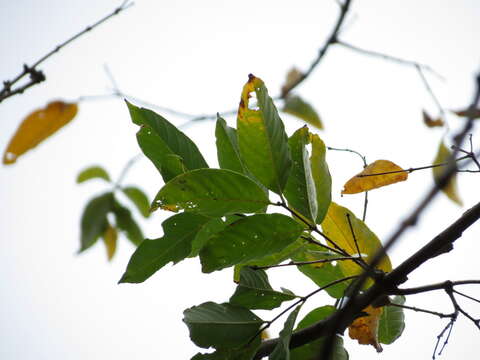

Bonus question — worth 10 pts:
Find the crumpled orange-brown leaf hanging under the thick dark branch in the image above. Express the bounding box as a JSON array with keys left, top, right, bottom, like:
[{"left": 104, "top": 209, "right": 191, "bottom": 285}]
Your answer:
[{"left": 348, "top": 306, "right": 383, "bottom": 352}]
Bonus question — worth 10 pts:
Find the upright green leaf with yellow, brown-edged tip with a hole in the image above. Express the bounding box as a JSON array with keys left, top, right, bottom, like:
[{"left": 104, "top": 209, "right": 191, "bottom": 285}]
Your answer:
[{"left": 237, "top": 75, "right": 291, "bottom": 194}]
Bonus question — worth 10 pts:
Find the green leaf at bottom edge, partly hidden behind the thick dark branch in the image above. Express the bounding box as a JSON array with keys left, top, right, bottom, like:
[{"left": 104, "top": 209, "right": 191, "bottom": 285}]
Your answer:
[{"left": 290, "top": 305, "right": 348, "bottom": 360}]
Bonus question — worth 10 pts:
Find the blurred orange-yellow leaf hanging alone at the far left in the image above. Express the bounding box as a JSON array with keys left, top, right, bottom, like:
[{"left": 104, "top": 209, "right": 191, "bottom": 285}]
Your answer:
[{"left": 3, "top": 101, "right": 78, "bottom": 165}]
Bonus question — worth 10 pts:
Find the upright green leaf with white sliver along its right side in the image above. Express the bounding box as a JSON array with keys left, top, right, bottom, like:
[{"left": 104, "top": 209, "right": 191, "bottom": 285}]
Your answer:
[{"left": 285, "top": 126, "right": 317, "bottom": 223}]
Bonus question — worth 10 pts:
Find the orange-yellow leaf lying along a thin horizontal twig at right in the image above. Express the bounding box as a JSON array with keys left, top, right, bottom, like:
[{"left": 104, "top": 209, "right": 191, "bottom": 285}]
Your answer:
[{"left": 342, "top": 160, "right": 408, "bottom": 194}]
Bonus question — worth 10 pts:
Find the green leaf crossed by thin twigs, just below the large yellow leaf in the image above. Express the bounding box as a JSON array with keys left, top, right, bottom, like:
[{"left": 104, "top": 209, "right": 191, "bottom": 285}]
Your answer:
[{"left": 291, "top": 244, "right": 350, "bottom": 299}]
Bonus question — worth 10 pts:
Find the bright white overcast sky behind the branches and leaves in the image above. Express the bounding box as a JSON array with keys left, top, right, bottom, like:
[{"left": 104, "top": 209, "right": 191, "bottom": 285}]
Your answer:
[{"left": 0, "top": 0, "right": 480, "bottom": 360}]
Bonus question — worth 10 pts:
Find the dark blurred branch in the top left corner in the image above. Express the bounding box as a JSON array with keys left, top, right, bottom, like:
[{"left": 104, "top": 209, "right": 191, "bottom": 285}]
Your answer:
[{"left": 0, "top": 0, "right": 133, "bottom": 103}]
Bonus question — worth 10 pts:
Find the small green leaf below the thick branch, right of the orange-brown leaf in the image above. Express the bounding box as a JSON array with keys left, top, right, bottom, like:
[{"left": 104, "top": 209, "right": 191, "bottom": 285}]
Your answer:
[{"left": 378, "top": 295, "right": 405, "bottom": 344}]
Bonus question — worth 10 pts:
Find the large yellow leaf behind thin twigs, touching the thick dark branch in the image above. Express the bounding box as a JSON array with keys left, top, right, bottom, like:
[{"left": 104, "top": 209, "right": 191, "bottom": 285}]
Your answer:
[{"left": 322, "top": 202, "right": 392, "bottom": 276}]
